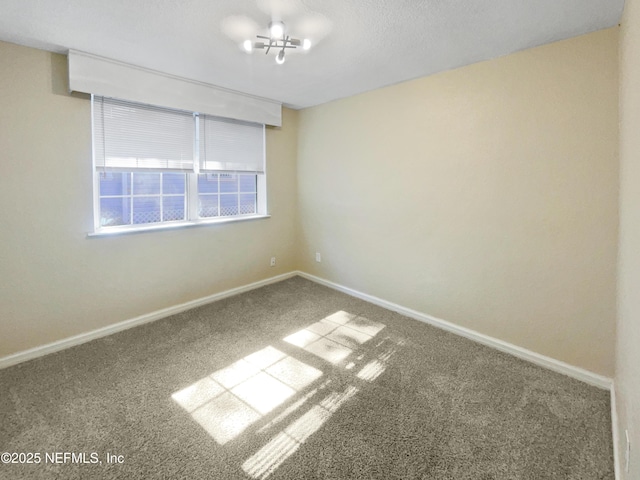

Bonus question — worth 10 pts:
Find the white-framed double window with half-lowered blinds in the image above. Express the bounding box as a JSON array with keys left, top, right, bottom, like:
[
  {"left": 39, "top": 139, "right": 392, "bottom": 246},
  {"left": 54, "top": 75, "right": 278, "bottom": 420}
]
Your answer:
[{"left": 92, "top": 96, "right": 266, "bottom": 232}]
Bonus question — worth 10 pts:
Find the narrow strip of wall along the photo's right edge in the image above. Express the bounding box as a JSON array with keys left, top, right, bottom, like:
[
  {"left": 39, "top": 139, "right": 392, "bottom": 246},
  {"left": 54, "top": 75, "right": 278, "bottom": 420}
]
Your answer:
[{"left": 615, "top": 0, "right": 640, "bottom": 480}]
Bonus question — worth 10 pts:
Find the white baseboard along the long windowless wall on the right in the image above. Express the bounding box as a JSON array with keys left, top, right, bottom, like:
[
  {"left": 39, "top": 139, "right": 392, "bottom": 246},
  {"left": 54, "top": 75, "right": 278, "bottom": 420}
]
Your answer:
[{"left": 296, "top": 272, "right": 613, "bottom": 390}]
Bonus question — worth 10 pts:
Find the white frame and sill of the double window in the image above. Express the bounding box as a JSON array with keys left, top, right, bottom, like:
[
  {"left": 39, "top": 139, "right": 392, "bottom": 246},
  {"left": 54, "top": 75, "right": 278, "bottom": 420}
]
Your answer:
[{"left": 88, "top": 95, "right": 270, "bottom": 237}]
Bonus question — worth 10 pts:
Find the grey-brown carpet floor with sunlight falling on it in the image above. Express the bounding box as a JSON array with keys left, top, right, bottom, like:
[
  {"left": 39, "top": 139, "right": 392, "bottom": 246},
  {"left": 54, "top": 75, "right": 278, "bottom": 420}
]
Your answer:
[{"left": 0, "top": 277, "right": 614, "bottom": 480}]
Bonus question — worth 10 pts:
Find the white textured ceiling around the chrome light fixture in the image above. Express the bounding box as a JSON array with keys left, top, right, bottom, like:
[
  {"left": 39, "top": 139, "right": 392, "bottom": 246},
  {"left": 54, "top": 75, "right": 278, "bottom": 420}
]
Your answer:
[{"left": 0, "top": 0, "right": 624, "bottom": 108}]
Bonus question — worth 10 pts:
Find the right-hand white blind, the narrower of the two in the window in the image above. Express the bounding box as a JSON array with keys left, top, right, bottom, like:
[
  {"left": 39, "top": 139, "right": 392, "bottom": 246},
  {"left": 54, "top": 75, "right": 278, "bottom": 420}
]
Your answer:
[{"left": 199, "top": 115, "right": 265, "bottom": 173}]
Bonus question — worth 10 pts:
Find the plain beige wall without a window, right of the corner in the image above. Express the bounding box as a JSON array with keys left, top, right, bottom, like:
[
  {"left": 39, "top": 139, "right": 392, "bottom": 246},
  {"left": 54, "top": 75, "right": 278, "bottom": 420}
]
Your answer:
[{"left": 298, "top": 28, "right": 618, "bottom": 376}]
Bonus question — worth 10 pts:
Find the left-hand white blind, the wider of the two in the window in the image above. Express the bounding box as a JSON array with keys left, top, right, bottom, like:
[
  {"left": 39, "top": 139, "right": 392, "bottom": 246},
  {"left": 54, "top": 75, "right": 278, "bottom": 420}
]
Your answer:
[{"left": 92, "top": 96, "right": 195, "bottom": 172}]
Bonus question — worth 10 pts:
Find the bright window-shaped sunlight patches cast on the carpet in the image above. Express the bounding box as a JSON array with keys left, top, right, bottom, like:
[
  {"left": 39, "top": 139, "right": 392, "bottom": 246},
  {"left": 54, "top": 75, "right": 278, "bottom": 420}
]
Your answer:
[{"left": 172, "top": 311, "right": 404, "bottom": 479}]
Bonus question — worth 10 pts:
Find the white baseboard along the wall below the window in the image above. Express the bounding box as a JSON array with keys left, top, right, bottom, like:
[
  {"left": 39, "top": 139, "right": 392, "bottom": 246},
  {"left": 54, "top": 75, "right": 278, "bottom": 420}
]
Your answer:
[{"left": 0, "top": 272, "right": 297, "bottom": 369}]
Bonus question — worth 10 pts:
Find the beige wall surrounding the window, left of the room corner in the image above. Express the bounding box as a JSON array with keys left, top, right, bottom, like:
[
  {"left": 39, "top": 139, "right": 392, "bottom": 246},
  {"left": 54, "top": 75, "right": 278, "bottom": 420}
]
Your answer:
[{"left": 0, "top": 42, "right": 298, "bottom": 357}]
